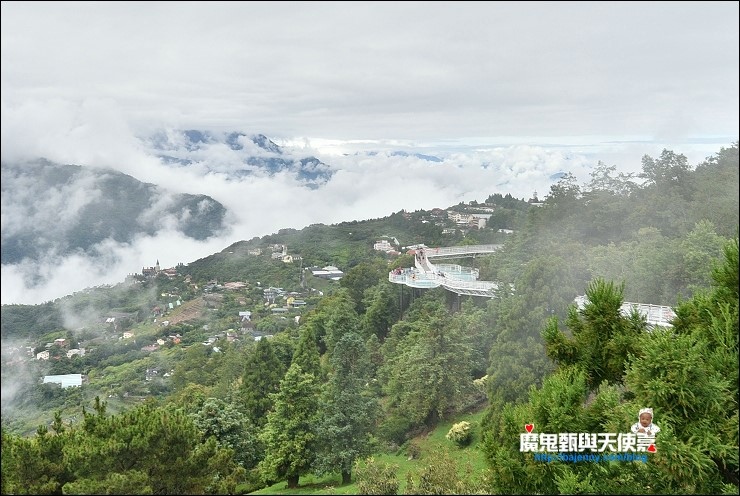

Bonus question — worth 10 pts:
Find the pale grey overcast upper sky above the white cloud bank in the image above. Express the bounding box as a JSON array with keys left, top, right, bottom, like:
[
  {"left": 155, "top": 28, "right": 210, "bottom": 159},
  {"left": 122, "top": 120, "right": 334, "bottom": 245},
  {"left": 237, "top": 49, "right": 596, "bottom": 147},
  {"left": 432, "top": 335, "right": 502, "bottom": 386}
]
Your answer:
[{"left": 2, "top": 2, "right": 739, "bottom": 140}]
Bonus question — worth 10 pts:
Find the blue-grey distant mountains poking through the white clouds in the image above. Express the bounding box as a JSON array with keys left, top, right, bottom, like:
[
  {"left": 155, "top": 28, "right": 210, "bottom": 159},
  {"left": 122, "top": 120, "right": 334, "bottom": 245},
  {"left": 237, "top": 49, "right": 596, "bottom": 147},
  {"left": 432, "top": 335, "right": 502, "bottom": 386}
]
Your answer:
[{"left": 2, "top": 130, "right": 344, "bottom": 272}]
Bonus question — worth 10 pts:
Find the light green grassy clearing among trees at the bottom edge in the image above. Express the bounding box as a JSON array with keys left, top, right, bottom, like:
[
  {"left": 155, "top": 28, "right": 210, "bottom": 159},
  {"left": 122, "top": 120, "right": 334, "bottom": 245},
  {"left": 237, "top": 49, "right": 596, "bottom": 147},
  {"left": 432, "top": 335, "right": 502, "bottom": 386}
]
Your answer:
[{"left": 250, "top": 410, "right": 487, "bottom": 495}]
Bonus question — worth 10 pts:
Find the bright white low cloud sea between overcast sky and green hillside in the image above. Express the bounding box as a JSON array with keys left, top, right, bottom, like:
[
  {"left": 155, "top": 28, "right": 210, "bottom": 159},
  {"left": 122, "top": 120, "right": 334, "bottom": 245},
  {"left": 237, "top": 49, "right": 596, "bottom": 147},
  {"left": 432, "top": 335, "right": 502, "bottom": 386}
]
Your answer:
[{"left": 2, "top": 100, "right": 729, "bottom": 304}]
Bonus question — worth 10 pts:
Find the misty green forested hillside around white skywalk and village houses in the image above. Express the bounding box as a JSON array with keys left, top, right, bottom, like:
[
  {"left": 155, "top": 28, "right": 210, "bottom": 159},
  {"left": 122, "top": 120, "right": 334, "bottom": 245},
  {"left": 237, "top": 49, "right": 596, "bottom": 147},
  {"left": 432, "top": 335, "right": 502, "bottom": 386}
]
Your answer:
[{"left": 2, "top": 143, "right": 740, "bottom": 494}]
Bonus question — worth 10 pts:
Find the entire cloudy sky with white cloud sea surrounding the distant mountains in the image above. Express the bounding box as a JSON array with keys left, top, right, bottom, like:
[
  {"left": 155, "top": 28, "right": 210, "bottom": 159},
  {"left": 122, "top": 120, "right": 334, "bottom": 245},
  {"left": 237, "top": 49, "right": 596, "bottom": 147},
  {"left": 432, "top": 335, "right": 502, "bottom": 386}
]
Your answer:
[{"left": 0, "top": 1, "right": 740, "bottom": 303}]
